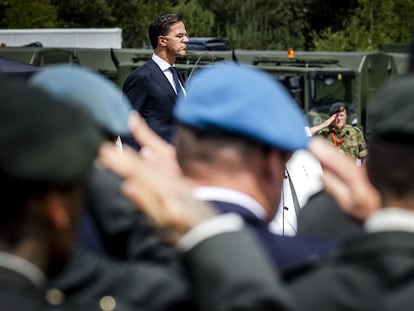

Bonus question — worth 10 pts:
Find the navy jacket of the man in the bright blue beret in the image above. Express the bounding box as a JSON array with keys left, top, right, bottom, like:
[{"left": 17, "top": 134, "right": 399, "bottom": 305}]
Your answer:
[{"left": 212, "top": 201, "right": 336, "bottom": 271}]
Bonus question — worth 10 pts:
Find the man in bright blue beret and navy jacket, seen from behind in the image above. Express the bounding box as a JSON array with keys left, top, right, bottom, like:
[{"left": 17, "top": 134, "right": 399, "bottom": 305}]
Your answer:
[{"left": 167, "top": 64, "right": 335, "bottom": 269}]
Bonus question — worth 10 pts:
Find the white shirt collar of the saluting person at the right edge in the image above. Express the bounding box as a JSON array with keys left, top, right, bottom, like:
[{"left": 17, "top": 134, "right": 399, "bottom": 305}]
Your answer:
[{"left": 364, "top": 207, "right": 414, "bottom": 233}]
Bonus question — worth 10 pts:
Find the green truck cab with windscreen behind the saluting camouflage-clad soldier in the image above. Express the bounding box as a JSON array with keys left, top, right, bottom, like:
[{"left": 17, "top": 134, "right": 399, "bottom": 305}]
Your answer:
[{"left": 253, "top": 57, "right": 358, "bottom": 126}]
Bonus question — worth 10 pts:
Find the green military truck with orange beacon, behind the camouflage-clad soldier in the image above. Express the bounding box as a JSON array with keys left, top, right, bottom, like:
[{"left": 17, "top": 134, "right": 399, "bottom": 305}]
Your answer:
[{"left": 236, "top": 50, "right": 404, "bottom": 136}]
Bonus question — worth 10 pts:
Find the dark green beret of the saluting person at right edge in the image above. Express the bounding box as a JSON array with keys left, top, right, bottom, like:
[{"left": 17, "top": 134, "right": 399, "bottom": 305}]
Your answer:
[{"left": 368, "top": 76, "right": 414, "bottom": 140}]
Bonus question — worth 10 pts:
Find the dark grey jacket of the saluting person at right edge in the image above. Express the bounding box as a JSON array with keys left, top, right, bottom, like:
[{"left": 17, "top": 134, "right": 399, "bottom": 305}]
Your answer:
[{"left": 289, "top": 232, "right": 414, "bottom": 310}]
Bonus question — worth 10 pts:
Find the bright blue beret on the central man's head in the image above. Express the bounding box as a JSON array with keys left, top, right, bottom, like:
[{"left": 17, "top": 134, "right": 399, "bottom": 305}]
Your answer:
[{"left": 174, "top": 63, "right": 309, "bottom": 151}]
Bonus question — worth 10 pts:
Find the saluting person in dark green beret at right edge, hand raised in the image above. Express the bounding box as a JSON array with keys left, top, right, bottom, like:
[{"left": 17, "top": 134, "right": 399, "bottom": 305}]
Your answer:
[{"left": 289, "top": 77, "right": 414, "bottom": 310}]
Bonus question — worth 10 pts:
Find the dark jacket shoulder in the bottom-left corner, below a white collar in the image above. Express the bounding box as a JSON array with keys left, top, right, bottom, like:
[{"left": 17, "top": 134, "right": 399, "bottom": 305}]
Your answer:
[{"left": 0, "top": 267, "right": 99, "bottom": 311}]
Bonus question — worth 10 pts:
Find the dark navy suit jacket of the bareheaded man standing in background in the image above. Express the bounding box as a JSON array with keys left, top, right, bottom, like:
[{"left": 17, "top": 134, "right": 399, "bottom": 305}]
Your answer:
[{"left": 122, "top": 59, "right": 177, "bottom": 147}]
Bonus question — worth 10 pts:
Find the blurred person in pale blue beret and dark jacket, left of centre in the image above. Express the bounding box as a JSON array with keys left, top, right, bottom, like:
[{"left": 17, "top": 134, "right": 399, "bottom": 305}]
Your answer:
[{"left": 30, "top": 65, "right": 191, "bottom": 310}]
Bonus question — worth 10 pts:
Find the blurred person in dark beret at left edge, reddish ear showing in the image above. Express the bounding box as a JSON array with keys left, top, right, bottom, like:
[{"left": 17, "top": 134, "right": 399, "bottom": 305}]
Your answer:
[{"left": 0, "top": 81, "right": 102, "bottom": 310}]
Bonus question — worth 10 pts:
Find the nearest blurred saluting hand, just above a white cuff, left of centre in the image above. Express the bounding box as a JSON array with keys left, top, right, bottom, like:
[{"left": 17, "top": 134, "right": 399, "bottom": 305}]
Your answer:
[{"left": 99, "top": 143, "right": 217, "bottom": 244}]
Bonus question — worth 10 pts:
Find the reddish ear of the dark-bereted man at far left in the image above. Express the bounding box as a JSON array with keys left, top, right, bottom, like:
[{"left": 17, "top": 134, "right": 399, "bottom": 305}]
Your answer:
[{"left": 44, "top": 191, "right": 70, "bottom": 229}]
